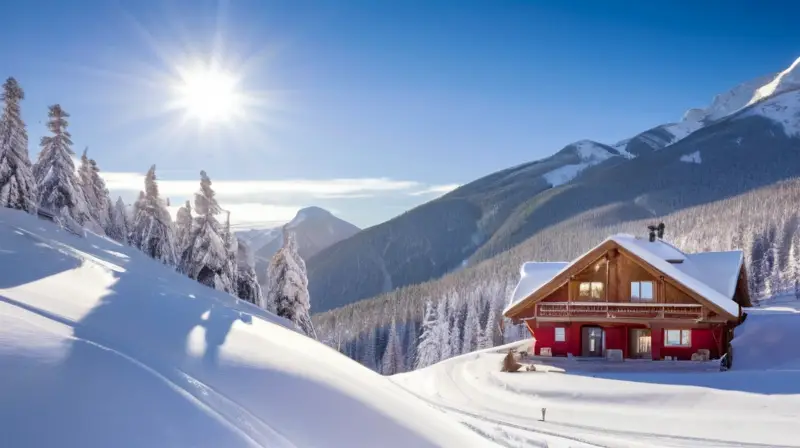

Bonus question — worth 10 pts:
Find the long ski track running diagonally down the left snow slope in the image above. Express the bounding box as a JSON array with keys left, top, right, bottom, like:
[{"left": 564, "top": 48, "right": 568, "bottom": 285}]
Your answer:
[{"left": 0, "top": 295, "right": 295, "bottom": 448}]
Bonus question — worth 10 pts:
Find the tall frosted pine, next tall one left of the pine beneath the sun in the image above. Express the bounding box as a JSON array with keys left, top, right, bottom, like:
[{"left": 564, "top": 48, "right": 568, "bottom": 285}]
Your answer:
[{"left": 129, "top": 165, "right": 177, "bottom": 266}]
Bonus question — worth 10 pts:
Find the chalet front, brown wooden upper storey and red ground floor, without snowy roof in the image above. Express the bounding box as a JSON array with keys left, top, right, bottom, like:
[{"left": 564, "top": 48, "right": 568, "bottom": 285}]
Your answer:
[{"left": 505, "top": 240, "right": 749, "bottom": 359}]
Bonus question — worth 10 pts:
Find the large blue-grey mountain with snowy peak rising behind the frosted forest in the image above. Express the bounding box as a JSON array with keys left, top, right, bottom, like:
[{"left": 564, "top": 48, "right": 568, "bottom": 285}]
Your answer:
[{"left": 308, "top": 59, "right": 800, "bottom": 311}]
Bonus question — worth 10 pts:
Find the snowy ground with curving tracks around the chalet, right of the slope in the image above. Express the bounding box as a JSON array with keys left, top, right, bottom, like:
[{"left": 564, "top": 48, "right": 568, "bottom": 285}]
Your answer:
[{"left": 392, "top": 301, "right": 800, "bottom": 447}]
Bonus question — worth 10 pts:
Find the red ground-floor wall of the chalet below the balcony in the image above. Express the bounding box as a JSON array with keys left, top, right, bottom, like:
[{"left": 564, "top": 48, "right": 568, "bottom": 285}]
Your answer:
[{"left": 528, "top": 321, "right": 725, "bottom": 360}]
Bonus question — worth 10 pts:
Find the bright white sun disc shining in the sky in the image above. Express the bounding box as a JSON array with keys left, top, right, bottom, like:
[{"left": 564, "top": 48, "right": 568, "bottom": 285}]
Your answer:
[{"left": 175, "top": 66, "right": 244, "bottom": 124}]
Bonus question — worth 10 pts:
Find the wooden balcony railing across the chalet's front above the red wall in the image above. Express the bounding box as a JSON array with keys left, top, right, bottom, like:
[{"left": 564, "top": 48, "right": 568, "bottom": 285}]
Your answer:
[{"left": 536, "top": 302, "right": 703, "bottom": 320}]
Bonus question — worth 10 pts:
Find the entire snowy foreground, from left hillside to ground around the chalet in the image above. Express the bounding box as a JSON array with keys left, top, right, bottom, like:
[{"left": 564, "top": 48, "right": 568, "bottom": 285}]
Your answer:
[{"left": 0, "top": 209, "right": 800, "bottom": 448}]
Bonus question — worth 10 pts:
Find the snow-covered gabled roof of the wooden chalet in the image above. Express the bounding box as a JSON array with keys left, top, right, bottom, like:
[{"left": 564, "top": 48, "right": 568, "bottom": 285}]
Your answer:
[{"left": 503, "top": 234, "right": 744, "bottom": 316}]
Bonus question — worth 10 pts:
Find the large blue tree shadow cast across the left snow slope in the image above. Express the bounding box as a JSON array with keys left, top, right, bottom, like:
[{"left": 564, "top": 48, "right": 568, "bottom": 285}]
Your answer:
[{"left": 0, "top": 257, "right": 255, "bottom": 447}]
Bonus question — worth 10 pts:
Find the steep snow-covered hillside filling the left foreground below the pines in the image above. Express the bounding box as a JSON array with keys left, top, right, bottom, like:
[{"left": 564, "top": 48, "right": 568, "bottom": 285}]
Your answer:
[{"left": 0, "top": 209, "right": 491, "bottom": 448}]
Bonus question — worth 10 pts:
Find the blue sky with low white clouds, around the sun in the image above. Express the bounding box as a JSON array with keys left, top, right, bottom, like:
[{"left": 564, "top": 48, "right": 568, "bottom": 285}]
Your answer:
[{"left": 0, "top": 0, "right": 800, "bottom": 226}]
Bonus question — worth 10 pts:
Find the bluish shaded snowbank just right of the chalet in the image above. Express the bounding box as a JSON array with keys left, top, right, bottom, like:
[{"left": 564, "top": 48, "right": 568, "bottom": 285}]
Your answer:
[{"left": 731, "top": 307, "right": 800, "bottom": 371}]
